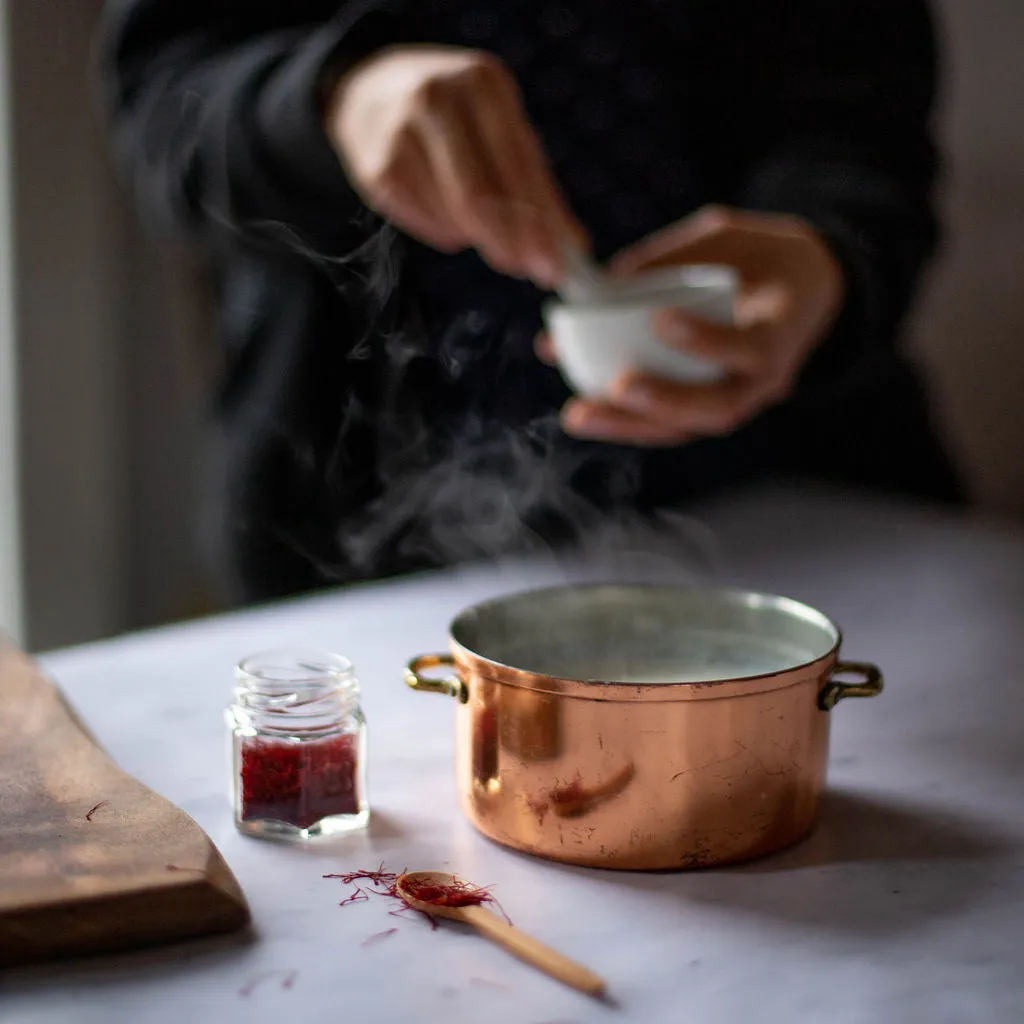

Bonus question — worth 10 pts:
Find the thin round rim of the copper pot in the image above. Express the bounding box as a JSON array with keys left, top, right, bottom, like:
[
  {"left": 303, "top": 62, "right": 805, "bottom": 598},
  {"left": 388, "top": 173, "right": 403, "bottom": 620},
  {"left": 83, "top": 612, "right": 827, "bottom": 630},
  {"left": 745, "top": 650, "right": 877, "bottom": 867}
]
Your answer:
[{"left": 449, "top": 583, "right": 843, "bottom": 702}]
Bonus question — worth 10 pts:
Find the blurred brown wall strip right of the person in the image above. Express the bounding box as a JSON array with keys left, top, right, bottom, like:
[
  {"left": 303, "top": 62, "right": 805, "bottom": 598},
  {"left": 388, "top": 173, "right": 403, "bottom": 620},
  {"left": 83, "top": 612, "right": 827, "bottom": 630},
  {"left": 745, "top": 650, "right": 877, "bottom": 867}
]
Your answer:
[{"left": 913, "top": 0, "right": 1024, "bottom": 519}]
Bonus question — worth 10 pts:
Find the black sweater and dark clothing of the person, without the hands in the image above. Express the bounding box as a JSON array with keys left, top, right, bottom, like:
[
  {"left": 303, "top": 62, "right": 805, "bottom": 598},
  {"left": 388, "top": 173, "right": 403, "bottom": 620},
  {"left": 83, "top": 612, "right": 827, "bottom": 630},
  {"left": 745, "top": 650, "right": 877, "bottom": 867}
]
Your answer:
[{"left": 100, "top": 0, "right": 958, "bottom": 599}]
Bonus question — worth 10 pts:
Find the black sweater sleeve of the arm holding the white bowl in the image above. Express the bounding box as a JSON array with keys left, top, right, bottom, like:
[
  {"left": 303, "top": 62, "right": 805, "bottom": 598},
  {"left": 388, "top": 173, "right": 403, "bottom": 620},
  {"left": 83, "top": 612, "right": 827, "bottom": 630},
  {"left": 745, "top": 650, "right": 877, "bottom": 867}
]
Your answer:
[{"left": 736, "top": 0, "right": 938, "bottom": 391}]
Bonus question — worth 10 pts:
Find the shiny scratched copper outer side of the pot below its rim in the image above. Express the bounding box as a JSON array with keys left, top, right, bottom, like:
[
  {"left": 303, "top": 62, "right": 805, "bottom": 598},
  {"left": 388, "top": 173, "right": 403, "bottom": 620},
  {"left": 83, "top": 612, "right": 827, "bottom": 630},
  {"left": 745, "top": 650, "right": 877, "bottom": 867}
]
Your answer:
[{"left": 456, "top": 651, "right": 834, "bottom": 870}]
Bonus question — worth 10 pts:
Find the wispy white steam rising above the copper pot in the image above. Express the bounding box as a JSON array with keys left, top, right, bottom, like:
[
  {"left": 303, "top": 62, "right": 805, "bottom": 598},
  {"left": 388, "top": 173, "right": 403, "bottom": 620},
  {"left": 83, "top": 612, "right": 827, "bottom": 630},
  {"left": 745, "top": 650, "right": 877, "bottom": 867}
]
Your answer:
[{"left": 205, "top": 209, "right": 717, "bottom": 583}]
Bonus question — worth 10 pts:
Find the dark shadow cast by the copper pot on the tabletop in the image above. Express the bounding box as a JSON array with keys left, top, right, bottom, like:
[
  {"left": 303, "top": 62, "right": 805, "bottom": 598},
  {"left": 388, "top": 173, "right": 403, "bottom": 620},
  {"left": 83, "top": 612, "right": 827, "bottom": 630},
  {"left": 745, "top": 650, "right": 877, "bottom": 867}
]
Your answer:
[{"left": 536, "top": 791, "right": 1024, "bottom": 937}]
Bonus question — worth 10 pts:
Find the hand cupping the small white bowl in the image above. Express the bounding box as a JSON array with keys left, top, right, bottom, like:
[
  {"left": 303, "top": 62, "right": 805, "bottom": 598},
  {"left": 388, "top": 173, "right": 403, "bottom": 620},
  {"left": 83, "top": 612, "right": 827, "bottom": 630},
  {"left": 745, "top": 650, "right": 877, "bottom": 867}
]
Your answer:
[{"left": 538, "top": 207, "right": 845, "bottom": 445}]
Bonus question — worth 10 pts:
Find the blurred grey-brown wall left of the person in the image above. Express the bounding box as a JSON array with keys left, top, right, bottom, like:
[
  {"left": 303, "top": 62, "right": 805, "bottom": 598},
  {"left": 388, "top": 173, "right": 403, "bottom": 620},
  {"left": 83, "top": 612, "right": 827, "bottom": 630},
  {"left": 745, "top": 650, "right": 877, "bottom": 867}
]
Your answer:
[{"left": 0, "top": 0, "right": 204, "bottom": 648}]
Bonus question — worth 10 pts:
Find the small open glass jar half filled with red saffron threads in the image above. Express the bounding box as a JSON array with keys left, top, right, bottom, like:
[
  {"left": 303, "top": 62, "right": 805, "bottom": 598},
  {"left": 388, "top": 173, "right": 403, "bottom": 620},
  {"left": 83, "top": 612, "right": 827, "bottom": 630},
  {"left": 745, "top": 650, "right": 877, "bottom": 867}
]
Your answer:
[{"left": 227, "top": 650, "right": 370, "bottom": 841}]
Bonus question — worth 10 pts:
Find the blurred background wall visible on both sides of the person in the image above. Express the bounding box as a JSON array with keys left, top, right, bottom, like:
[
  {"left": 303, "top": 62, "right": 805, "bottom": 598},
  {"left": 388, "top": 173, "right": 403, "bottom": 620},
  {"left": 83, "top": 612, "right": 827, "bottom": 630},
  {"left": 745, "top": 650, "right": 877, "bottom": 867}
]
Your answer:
[{"left": 0, "top": 0, "right": 1024, "bottom": 648}]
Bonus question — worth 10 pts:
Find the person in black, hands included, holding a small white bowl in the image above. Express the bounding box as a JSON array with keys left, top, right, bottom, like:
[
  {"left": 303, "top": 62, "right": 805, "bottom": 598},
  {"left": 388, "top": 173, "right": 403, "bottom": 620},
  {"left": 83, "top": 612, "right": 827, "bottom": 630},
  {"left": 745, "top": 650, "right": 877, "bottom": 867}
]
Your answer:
[{"left": 99, "top": 0, "right": 963, "bottom": 601}]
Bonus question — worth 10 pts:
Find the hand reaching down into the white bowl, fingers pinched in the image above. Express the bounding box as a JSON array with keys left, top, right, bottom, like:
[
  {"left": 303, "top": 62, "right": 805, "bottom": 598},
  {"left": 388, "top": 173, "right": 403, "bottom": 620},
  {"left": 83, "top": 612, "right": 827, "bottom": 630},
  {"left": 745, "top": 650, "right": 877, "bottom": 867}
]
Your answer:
[{"left": 325, "top": 46, "right": 585, "bottom": 287}]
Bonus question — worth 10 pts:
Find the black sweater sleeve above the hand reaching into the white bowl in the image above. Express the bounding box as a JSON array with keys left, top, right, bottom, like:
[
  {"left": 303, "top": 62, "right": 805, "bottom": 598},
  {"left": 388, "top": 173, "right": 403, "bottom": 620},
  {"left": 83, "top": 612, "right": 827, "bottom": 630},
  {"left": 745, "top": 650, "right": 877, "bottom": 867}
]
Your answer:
[{"left": 98, "top": 0, "right": 409, "bottom": 256}]
